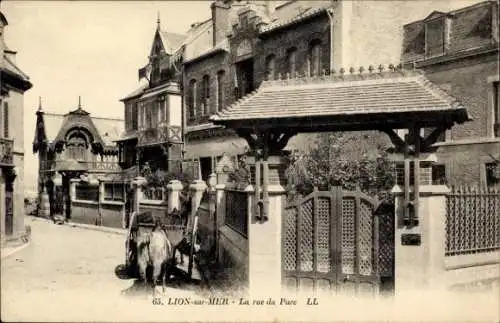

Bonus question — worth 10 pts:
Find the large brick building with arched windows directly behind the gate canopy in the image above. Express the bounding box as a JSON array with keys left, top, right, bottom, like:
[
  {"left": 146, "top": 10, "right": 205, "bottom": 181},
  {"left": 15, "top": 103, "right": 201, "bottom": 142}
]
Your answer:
[{"left": 182, "top": 0, "right": 480, "bottom": 178}]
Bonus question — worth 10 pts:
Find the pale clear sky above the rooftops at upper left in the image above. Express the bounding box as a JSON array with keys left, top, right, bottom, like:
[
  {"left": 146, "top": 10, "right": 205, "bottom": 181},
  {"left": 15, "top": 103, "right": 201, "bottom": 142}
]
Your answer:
[{"left": 0, "top": 0, "right": 211, "bottom": 195}]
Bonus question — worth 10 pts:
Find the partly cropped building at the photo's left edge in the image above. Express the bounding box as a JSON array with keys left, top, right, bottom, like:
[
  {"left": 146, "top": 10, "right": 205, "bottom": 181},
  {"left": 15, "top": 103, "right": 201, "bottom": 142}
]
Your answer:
[{"left": 0, "top": 8, "right": 32, "bottom": 243}]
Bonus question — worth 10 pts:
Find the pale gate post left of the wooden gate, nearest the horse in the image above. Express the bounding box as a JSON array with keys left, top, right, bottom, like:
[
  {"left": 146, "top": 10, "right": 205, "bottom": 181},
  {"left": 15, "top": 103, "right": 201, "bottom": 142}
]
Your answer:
[{"left": 246, "top": 156, "right": 286, "bottom": 297}]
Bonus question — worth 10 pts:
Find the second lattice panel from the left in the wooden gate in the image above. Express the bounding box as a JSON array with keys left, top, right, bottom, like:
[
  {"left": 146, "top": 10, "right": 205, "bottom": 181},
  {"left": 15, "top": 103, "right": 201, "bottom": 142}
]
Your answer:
[{"left": 299, "top": 199, "right": 313, "bottom": 271}]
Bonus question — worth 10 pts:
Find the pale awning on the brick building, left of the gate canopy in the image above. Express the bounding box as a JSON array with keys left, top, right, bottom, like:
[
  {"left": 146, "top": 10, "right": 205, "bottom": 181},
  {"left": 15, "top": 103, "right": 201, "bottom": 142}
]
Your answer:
[{"left": 184, "top": 138, "right": 248, "bottom": 159}]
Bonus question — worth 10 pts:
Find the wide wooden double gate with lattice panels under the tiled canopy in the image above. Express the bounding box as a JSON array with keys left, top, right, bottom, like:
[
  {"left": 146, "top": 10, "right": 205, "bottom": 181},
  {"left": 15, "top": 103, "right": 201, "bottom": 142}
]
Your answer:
[{"left": 282, "top": 187, "right": 394, "bottom": 294}]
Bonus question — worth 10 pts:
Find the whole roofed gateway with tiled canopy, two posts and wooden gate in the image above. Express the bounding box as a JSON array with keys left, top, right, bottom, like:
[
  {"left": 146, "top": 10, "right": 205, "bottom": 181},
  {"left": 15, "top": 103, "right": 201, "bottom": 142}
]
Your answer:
[{"left": 211, "top": 65, "right": 470, "bottom": 293}]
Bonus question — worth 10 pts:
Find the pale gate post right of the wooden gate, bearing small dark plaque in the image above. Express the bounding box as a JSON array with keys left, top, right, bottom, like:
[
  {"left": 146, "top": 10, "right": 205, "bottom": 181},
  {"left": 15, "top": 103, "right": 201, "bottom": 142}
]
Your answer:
[{"left": 392, "top": 163, "right": 450, "bottom": 295}]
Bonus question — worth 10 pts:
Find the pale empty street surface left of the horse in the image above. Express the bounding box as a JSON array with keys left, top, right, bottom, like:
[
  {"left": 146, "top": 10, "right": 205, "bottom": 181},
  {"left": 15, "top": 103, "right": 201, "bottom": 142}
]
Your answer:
[{"left": 1, "top": 217, "right": 209, "bottom": 321}]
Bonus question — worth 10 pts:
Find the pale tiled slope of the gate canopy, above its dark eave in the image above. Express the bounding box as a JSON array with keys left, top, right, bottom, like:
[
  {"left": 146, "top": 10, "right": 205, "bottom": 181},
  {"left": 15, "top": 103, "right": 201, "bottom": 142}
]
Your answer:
[{"left": 211, "top": 70, "right": 469, "bottom": 131}]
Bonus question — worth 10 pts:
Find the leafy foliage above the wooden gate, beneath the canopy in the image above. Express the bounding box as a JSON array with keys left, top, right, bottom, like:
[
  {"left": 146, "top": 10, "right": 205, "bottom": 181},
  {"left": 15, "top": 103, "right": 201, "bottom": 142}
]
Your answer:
[{"left": 287, "top": 133, "right": 394, "bottom": 200}]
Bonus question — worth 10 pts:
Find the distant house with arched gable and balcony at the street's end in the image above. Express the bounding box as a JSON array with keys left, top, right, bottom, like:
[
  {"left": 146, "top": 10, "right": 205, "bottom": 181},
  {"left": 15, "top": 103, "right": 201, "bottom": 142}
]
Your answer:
[{"left": 33, "top": 102, "right": 125, "bottom": 227}]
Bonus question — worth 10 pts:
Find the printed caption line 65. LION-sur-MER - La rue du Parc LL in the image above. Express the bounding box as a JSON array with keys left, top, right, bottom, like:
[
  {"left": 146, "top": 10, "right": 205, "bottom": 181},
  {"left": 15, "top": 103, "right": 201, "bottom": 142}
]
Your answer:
[{"left": 153, "top": 297, "right": 319, "bottom": 306}]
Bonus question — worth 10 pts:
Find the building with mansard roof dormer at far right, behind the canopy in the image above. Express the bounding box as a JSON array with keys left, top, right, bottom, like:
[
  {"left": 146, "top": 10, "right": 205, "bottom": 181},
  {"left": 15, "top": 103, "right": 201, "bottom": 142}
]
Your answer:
[{"left": 402, "top": 1, "right": 500, "bottom": 186}]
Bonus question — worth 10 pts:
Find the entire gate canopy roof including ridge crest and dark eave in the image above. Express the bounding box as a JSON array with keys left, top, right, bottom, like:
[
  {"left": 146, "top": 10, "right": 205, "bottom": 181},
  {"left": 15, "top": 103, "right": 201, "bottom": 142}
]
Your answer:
[{"left": 211, "top": 68, "right": 470, "bottom": 132}]
